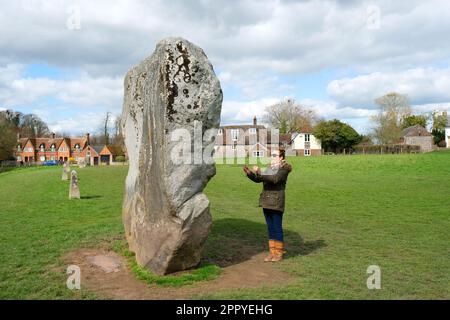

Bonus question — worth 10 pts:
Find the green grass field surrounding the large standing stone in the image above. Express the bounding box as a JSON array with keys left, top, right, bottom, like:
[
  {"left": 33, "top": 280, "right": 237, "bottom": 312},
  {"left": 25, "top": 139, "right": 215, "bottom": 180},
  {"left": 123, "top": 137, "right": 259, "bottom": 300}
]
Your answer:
[{"left": 0, "top": 152, "right": 450, "bottom": 299}]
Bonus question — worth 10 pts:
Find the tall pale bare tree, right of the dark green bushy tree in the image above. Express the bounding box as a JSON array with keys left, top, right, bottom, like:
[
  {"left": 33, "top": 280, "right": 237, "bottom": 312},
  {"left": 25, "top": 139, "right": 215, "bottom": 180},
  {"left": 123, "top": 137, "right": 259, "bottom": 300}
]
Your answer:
[{"left": 372, "top": 92, "right": 411, "bottom": 144}]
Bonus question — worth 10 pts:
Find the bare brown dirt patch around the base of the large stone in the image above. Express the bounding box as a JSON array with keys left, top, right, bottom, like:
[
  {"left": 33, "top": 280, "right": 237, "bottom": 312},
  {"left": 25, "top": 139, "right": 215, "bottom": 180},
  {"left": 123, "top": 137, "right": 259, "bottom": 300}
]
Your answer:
[{"left": 63, "top": 249, "right": 293, "bottom": 300}]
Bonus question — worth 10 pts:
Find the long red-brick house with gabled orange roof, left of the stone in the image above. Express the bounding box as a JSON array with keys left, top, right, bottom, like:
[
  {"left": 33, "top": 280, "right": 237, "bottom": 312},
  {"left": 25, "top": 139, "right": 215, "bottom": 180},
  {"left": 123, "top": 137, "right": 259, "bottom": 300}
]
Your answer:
[{"left": 14, "top": 133, "right": 125, "bottom": 165}]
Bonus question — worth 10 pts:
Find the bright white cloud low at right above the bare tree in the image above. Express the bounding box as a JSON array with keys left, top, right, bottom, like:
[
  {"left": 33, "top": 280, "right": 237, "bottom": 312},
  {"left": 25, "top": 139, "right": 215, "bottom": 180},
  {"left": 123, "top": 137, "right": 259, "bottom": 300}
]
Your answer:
[{"left": 327, "top": 68, "right": 450, "bottom": 108}]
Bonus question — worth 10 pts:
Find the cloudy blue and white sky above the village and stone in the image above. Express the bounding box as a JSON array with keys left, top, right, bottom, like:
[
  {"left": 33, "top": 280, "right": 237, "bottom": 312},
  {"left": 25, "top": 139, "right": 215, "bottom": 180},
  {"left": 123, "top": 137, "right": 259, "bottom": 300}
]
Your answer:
[{"left": 0, "top": 0, "right": 450, "bottom": 134}]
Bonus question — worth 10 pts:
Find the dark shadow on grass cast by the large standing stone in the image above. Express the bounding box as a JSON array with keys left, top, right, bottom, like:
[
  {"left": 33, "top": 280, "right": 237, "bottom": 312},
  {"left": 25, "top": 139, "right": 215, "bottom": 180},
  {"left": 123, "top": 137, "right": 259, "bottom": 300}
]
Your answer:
[{"left": 203, "top": 218, "right": 327, "bottom": 267}]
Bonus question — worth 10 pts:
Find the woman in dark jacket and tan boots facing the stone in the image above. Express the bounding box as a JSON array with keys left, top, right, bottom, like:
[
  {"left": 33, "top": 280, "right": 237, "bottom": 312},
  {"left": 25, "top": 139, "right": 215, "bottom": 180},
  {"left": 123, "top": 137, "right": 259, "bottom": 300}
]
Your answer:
[{"left": 244, "top": 150, "right": 292, "bottom": 262}]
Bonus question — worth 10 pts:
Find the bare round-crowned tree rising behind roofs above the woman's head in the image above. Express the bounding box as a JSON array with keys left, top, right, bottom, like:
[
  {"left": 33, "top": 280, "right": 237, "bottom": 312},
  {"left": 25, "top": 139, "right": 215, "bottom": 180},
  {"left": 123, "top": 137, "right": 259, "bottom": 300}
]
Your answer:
[{"left": 264, "top": 99, "right": 317, "bottom": 134}]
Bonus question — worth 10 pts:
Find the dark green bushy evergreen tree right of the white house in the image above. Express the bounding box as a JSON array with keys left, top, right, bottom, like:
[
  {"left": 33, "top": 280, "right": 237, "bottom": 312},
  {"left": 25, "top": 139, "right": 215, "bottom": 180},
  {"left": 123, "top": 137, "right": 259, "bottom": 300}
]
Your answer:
[{"left": 313, "top": 119, "right": 363, "bottom": 153}]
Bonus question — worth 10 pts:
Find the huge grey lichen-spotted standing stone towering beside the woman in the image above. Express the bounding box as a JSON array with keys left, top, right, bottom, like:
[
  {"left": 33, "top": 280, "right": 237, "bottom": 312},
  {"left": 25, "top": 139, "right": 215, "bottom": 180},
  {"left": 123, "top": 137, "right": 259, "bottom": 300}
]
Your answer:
[{"left": 122, "top": 38, "right": 222, "bottom": 275}]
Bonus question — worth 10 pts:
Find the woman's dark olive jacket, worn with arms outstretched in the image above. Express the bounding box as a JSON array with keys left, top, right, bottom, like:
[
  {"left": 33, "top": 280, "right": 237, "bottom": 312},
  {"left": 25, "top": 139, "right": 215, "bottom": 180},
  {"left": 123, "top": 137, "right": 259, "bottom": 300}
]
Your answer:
[{"left": 247, "top": 162, "right": 292, "bottom": 212}]
